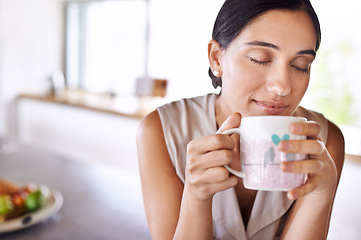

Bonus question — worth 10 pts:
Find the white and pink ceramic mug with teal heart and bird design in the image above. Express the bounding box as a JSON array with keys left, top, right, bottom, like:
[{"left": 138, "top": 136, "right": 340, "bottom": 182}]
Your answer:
[{"left": 223, "top": 116, "right": 307, "bottom": 191}]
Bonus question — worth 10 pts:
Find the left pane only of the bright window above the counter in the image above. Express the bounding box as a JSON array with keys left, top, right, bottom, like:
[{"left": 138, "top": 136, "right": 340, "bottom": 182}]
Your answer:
[{"left": 66, "top": 0, "right": 147, "bottom": 94}]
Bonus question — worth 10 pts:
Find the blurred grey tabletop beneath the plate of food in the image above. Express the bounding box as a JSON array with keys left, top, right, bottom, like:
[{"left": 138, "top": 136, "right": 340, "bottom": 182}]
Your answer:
[{"left": 0, "top": 147, "right": 150, "bottom": 240}]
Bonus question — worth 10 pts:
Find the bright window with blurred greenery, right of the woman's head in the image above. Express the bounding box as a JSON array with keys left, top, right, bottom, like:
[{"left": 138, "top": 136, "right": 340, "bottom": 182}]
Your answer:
[{"left": 303, "top": 0, "right": 361, "bottom": 127}]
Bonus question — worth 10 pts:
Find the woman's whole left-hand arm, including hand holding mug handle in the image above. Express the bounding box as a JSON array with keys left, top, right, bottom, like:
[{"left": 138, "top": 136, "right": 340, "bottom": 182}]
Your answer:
[{"left": 137, "top": 111, "right": 240, "bottom": 239}]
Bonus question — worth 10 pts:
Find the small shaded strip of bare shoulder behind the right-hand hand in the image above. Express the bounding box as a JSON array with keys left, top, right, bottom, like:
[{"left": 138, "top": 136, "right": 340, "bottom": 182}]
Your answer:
[{"left": 326, "top": 121, "right": 345, "bottom": 179}]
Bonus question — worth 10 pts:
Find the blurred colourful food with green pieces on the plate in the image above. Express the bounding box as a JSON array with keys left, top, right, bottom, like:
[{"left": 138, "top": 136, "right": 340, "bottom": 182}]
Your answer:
[{"left": 0, "top": 179, "right": 51, "bottom": 223}]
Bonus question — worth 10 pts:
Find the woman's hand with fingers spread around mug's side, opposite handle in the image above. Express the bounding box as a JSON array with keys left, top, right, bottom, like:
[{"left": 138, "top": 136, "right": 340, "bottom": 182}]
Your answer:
[{"left": 279, "top": 122, "right": 338, "bottom": 200}]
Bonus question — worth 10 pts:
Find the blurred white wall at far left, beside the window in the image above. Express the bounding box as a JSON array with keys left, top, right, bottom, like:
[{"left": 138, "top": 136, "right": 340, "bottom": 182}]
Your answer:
[{"left": 0, "top": 0, "right": 64, "bottom": 138}]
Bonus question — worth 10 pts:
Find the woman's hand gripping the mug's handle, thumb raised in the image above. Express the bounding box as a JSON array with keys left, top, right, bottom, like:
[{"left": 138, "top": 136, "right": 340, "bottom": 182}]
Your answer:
[{"left": 185, "top": 113, "right": 241, "bottom": 200}]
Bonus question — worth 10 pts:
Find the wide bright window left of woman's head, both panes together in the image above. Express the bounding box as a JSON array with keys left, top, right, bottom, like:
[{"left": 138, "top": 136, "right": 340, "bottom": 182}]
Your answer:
[{"left": 66, "top": 0, "right": 223, "bottom": 99}]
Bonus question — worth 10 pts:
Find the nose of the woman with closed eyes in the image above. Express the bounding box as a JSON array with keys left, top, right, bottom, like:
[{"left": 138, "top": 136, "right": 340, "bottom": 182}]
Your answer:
[{"left": 266, "top": 65, "right": 291, "bottom": 96}]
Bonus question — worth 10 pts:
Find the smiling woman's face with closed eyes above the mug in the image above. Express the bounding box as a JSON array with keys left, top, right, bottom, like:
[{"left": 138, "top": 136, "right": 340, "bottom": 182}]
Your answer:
[{"left": 220, "top": 10, "right": 316, "bottom": 116}]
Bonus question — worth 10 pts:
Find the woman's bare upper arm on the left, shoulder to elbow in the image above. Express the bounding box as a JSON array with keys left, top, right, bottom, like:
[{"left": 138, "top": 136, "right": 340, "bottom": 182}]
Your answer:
[{"left": 137, "top": 111, "right": 183, "bottom": 239}]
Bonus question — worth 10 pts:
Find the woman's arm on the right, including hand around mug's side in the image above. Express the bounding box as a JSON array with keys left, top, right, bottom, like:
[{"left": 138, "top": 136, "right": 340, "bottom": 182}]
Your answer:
[{"left": 282, "top": 122, "right": 345, "bottom": 240}]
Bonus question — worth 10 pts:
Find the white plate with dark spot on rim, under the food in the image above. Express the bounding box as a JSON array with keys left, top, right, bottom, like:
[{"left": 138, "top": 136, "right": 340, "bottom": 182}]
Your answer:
[{"left": 0, "top": 190, "right": 64, "bottom": 233}]
